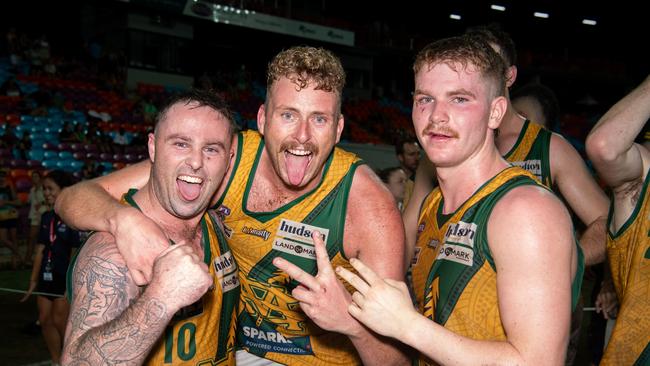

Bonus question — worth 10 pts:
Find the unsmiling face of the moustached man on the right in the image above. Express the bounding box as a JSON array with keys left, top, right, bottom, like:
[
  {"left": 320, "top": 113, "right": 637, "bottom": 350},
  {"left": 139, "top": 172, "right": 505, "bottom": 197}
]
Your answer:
[{"left": 412, "top": 62, "right": 505, "bottom": 167}]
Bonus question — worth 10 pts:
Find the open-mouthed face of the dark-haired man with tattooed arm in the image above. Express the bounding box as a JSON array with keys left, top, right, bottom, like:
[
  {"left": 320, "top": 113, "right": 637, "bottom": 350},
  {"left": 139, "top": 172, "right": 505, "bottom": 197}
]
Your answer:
[{"left": 149, "top": 102, "right": 231, "bottom": 219}]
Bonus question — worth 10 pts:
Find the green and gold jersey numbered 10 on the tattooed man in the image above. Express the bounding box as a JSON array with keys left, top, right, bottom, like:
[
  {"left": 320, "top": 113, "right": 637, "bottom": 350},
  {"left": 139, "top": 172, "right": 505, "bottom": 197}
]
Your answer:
[{"left": 68, "top": 189, "right": 239, "bottom": 365}]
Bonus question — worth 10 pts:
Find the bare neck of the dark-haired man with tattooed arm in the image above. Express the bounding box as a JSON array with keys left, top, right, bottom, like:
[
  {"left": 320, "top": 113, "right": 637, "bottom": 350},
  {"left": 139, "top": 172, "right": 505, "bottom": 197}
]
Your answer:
[{"left": 133, "top": 181, "right": 203, "bottom": 246}]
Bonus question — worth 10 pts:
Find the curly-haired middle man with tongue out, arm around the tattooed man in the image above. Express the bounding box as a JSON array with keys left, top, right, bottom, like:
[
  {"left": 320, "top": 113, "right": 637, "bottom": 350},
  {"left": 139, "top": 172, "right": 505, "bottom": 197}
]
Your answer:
[{"left": 57, "top": 47, "right": 406, "bottom": 365}]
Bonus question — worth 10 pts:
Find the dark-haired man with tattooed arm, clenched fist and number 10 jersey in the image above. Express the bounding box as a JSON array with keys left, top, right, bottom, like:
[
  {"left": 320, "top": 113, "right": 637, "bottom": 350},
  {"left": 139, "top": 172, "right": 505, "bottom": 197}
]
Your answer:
[{"left": 63, "top": 91, "right": 239, "bottom": 365}]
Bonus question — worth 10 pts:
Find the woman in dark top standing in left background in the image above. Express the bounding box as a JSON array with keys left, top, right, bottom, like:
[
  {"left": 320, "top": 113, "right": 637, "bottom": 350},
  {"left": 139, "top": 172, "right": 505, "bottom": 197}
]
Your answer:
[{"left": 21, "top": 170, "right": 80, "bottom": 365}]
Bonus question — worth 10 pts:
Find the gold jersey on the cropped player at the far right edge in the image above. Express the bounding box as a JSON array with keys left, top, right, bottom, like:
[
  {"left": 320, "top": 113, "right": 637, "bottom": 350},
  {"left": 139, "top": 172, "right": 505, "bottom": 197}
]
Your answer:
[{"left": 601, "top": 172, "right": 650, "bottom": 365}]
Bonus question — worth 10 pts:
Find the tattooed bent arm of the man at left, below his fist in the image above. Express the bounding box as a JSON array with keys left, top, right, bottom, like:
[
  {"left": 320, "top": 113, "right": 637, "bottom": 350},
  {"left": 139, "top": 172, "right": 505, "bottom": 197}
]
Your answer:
[{"left": 64, "top": 243, "right": 173, "bottom": 365}]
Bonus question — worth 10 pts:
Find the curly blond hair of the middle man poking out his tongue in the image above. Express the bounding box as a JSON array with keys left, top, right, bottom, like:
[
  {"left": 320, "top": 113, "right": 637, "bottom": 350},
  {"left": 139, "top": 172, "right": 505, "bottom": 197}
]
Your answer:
[{"left": 266, "top": 46, "right": 345, "bottom": 98}]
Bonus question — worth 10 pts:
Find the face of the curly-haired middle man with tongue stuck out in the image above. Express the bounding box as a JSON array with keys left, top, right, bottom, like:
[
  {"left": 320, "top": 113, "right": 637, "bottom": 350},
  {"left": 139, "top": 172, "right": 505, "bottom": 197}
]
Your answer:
[{"left": 257, "top": 77, "right": 344, "bottom": 189}]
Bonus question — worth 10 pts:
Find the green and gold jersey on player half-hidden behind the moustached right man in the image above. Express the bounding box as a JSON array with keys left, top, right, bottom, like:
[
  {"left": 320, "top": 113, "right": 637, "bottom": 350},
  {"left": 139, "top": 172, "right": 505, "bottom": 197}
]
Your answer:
[{"left": 503, "top": 120, "right": 553, "bottom": 188}]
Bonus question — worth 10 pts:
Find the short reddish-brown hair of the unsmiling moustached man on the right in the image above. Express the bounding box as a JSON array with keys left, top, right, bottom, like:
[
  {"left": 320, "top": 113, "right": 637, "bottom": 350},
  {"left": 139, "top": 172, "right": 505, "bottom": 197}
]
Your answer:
[{"left": 413, "top": 34, "right": 506, "bottom": 96}]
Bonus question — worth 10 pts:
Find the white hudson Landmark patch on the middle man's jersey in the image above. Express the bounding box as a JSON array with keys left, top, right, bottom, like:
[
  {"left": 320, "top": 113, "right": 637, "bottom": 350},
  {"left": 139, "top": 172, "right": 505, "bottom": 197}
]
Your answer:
[{"left": 273, "top": 219, "right": 329, "bottom": 259}]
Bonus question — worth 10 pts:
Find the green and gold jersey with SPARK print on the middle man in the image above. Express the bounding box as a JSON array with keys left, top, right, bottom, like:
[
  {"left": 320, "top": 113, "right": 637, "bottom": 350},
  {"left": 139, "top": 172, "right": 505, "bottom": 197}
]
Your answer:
[{"left": 218, "top": 131, "right": 361, "bottom": 365}]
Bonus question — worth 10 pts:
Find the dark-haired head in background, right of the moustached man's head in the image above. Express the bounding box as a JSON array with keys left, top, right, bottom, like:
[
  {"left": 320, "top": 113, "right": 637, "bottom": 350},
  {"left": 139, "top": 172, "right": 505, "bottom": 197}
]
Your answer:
[{"left": 512, "top": 83, "right": 560, "bottom": 131}]
